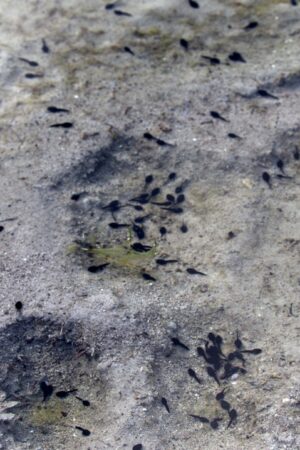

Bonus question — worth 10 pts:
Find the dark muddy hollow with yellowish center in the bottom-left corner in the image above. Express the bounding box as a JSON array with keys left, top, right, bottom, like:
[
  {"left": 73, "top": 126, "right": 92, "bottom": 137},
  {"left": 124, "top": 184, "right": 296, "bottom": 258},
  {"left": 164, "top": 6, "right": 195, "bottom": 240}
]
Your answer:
[{"left": 0, "top": 317, "right": 106, "bottom": 448}]
